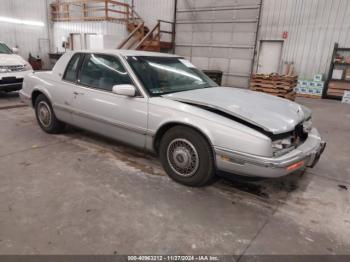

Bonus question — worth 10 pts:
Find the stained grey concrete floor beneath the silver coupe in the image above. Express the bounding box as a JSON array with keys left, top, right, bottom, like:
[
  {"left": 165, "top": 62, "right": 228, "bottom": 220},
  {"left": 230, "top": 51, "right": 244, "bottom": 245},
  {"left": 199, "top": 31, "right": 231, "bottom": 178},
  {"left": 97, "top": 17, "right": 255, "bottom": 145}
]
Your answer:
[{"left": 0, "top": 95, "right": 350, "bottom": 255}]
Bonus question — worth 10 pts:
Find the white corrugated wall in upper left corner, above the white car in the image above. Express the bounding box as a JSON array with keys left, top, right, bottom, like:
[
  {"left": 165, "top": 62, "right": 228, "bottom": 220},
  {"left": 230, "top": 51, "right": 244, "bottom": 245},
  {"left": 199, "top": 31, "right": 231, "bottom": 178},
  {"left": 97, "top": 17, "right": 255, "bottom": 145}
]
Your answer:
[{"left": 0, "top": 0, "right": 50, "bottom": 66}]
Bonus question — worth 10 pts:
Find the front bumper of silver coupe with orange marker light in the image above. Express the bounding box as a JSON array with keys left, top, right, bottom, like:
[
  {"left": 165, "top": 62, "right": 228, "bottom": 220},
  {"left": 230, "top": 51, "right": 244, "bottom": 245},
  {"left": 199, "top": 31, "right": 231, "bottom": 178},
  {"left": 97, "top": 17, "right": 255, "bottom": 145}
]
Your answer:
[{"left": 214, "top": 128, "right": 326, "bottom": 177}]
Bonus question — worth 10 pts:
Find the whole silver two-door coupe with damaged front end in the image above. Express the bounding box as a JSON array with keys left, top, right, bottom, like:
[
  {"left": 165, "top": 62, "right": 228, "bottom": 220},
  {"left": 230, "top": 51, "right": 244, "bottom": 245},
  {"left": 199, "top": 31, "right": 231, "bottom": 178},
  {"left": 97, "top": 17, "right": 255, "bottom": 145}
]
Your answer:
[{"left": 20, "top": 50, "right": 326, "bottom": 186}]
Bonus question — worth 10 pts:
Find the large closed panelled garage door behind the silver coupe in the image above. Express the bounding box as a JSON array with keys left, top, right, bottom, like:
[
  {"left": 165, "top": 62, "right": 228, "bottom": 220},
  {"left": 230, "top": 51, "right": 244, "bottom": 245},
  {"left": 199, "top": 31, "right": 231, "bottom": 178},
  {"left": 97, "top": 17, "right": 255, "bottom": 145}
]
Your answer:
[{"left": 176, "top": 0, "right": 261, "bottom": 88}]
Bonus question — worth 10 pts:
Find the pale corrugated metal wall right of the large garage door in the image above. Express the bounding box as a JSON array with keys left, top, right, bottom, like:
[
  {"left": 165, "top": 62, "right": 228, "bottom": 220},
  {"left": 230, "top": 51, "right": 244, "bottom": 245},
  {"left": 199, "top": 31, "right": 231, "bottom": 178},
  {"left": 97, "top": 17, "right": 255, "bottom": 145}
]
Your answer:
[{"left": 256, "top": 0, "right": 350, "bottom": 79}]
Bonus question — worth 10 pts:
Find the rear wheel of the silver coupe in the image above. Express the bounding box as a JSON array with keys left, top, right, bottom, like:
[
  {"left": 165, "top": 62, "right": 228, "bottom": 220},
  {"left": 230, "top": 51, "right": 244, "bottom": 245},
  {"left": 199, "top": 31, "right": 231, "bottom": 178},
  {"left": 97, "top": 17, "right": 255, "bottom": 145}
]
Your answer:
[{"left": 34, "top": 94, "right": 65, "bottom": 134}]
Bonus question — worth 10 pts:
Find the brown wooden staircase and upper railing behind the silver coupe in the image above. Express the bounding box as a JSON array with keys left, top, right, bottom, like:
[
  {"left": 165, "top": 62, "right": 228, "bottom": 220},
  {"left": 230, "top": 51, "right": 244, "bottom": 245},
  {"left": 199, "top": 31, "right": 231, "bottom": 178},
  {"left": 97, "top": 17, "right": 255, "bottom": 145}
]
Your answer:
[{"left": 50, "top": 0, "right": 175, "bottom": 52}]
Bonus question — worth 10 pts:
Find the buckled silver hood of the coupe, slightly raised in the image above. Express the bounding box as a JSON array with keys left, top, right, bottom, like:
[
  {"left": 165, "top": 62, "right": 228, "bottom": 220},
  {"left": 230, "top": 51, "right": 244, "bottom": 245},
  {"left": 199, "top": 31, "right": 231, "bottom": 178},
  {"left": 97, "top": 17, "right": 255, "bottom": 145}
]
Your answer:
[{"left": 163, "top": 87, "right": 311, "bottom": 134}]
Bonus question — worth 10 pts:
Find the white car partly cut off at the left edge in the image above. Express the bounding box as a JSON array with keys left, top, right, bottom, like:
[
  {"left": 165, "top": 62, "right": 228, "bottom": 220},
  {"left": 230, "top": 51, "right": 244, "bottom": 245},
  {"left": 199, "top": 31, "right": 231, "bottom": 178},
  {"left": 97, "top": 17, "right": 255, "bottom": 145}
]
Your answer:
[{"left": 0, "top": 42, "right": 33, "bottom": 92}]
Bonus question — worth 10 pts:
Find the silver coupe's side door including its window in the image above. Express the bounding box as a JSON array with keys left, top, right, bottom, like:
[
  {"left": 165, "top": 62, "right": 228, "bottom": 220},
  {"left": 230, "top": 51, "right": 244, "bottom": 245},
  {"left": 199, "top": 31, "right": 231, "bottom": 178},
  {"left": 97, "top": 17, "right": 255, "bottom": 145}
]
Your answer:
[{"left": 73, "top": 54, "right": 148, "bottom": 147}]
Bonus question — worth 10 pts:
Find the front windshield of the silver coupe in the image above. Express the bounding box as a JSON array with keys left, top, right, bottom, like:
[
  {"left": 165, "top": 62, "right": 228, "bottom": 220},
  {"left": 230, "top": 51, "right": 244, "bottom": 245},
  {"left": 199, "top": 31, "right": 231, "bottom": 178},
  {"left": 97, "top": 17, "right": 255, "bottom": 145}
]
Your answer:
[{"left": 127, "top": 56, "right": 217, "bottom": 96}]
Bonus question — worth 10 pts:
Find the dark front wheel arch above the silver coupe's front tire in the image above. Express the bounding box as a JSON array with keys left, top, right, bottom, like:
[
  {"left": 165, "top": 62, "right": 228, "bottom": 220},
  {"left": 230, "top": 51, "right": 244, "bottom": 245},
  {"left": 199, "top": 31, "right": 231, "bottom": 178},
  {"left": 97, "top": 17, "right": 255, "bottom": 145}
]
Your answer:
[{"left": 153, "top": 121, "right": 215, "bottom": 159}]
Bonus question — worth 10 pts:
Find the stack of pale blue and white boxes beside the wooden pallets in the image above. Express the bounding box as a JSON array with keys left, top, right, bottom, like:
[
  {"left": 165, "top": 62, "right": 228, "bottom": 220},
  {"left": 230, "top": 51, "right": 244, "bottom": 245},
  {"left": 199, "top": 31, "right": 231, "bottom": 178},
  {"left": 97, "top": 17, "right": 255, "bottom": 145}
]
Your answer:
[{"left": 295, "top": 74, "right": 324, "bottom": 98}]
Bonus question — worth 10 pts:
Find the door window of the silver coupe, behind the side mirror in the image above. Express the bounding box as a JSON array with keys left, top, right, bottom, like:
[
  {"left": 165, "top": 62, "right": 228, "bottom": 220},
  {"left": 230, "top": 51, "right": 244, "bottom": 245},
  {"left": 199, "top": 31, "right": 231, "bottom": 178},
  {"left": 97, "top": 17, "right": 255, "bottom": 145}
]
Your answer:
[{"left": 79, "top": 54, "right": 132, "bottom": 91}]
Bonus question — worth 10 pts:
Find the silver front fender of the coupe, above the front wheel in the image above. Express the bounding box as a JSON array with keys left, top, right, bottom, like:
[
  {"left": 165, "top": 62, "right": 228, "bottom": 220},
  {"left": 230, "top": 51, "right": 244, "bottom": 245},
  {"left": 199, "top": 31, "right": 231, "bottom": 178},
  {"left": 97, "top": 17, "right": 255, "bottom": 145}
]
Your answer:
[{"left": 146, "top": 99, "right": 272, "bottom": 156}]
